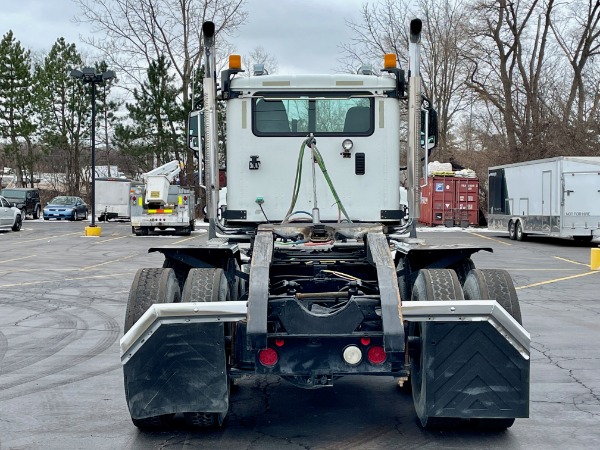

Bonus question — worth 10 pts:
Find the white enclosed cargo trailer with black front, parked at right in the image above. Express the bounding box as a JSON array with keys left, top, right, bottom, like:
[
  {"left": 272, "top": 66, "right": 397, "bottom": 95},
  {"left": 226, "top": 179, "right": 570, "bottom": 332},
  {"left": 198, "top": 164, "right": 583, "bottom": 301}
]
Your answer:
[{"left": 488, "top": 156, "right": 600, "bottom": 242}]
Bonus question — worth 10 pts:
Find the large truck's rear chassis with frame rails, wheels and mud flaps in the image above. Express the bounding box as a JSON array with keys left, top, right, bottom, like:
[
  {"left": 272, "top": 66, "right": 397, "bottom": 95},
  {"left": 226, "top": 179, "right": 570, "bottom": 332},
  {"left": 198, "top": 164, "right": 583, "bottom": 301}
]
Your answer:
[{"left": 121, "top": 224, "right": 530, "bottom": 429}]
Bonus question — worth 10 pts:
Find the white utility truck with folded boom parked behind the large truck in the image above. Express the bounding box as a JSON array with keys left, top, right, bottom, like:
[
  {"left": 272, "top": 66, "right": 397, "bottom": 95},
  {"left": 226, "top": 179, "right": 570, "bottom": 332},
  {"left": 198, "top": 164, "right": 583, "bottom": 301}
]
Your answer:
[{"left": 130, "top": 160, "right": 195, "bottom": 236}]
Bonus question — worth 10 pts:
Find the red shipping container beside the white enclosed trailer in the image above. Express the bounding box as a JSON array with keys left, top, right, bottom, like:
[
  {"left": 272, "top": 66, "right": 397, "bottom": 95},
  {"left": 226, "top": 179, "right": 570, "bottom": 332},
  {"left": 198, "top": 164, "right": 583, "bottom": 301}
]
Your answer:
[{"left": 419, "top": 175, "right": 479, "bottom": 228}]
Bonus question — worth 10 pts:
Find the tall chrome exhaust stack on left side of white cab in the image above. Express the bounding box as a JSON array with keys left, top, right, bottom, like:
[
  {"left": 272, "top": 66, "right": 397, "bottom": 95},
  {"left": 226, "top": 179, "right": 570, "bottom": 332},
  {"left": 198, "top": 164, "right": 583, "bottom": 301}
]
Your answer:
[{"left": 202, "top": 22, "right": 219, "bottom": 239}]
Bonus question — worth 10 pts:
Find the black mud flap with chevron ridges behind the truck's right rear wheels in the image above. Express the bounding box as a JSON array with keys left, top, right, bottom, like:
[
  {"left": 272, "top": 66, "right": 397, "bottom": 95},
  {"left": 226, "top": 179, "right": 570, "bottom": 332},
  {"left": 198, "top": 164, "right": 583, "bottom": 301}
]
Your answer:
[{"left": 421, "top": 322, "right": 530, "bottom": 418}]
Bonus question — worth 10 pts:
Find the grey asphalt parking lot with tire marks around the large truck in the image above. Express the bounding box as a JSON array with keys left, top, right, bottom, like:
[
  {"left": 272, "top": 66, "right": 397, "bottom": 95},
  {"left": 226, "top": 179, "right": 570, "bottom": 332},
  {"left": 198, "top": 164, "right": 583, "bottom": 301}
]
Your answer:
[{"left": 0, "top": 220, "right": 600, "bottom": 449}]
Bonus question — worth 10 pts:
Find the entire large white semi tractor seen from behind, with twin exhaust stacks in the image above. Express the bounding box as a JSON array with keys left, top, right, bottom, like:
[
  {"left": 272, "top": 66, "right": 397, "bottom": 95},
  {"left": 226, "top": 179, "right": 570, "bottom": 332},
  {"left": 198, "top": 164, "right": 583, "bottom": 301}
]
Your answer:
[{"left": 120, "top": 19, "right": 530, "bottom": 430}]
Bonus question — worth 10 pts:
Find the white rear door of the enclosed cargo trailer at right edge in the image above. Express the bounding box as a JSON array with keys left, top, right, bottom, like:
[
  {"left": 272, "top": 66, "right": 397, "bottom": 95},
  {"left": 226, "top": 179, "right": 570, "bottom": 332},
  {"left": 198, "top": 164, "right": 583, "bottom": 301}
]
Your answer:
[{"left": 563, "top": 172, "right": 600, "bottom": 228}]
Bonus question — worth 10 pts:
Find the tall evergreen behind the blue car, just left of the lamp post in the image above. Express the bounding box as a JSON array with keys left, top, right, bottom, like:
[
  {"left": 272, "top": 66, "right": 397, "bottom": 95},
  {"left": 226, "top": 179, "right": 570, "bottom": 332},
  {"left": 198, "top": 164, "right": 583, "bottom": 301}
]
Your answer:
[{"left": 34, "top": 37, "right": 91, "bottom": 195}]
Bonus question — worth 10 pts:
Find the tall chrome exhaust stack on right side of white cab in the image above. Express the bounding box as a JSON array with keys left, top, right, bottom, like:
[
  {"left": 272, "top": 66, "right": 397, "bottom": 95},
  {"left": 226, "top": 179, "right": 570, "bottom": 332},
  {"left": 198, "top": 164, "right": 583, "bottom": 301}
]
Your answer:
[{"left": 406, "top": 19, "right": 423, "bottom": 237}]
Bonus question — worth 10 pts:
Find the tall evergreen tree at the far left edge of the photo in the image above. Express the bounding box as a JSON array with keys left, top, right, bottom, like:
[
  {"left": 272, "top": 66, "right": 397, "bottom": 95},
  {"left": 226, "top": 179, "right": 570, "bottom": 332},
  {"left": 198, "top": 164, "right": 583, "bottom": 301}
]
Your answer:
[{"left": 0, "top": 31, "right": 35, "bottom": 186}]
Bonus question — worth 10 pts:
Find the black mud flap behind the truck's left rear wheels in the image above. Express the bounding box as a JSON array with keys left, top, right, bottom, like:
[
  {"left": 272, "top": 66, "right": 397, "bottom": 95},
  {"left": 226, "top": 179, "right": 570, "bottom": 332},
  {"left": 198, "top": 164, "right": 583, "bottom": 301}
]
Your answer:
[{"left": 123, "top": 323, "right": 229, "bottom": 419}]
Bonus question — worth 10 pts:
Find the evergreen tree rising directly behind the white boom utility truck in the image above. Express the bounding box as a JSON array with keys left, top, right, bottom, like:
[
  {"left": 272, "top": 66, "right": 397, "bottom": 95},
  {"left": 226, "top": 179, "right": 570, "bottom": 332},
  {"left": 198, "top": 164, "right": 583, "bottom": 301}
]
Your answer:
[{"left": 116, "top": 56, "right": 186, "bottom": 171}]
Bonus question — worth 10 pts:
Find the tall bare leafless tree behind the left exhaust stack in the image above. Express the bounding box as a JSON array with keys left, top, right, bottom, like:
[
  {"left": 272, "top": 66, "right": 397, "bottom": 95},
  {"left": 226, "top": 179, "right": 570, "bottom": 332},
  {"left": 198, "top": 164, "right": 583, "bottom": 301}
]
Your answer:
[{"left": 75, "top": 0, "right": 246, "bottom": 184}]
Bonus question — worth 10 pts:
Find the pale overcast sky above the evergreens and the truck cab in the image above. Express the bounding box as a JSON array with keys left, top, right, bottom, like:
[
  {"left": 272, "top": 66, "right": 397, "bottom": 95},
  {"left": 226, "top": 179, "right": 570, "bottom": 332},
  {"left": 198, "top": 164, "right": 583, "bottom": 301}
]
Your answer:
[{"left": 0, "top": 0, "right": 365, "bottom": 73}]
